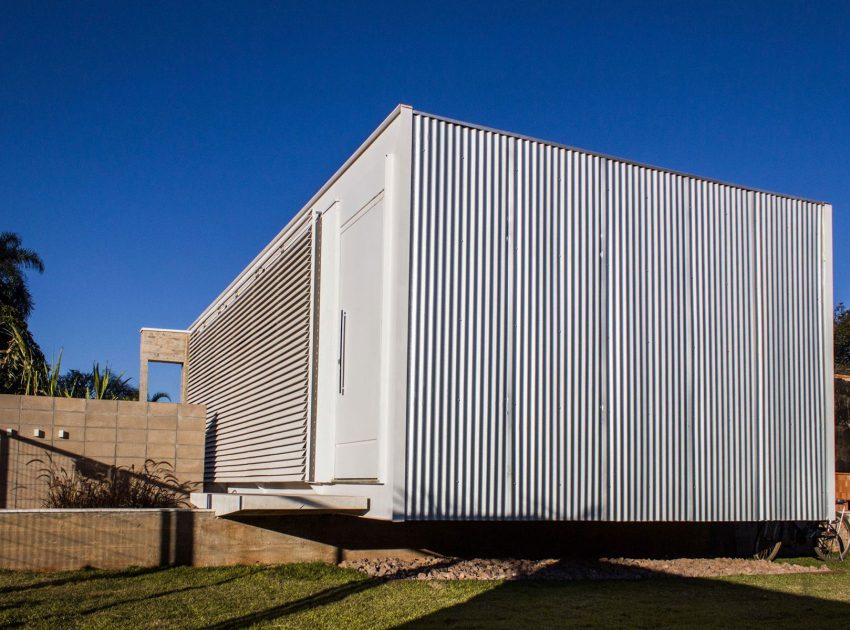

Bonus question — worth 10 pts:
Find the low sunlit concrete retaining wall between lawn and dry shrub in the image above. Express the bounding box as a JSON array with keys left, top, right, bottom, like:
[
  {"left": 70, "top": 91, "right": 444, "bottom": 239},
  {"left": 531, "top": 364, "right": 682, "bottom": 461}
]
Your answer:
[{"left": 0, "top": 510, "right": 337, "bottom": 571}]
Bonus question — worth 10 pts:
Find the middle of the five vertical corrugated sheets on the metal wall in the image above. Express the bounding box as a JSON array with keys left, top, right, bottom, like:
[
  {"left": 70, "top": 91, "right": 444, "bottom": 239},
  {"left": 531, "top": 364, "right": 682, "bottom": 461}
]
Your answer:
[{"left": 606, "top": 161, "right": 693, "bottom": 520}]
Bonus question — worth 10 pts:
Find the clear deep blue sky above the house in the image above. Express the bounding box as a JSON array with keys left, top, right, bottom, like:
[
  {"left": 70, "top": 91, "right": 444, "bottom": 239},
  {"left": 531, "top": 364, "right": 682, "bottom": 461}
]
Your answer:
[{"left": 0, "top": 1, "right": 850, "bottom": 402}]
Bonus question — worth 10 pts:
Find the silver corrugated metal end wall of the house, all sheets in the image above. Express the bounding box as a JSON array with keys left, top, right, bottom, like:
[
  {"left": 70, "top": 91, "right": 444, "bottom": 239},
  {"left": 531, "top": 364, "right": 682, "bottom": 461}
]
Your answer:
[{"left": 406, "top": 114, "right": 832, "bottom": 521}]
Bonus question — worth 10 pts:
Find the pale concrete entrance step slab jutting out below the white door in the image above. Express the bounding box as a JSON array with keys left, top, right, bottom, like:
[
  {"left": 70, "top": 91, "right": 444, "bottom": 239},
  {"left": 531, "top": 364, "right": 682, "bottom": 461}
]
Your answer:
[{"left": 189, "top": 492, "right": 369, "bottom": 516}]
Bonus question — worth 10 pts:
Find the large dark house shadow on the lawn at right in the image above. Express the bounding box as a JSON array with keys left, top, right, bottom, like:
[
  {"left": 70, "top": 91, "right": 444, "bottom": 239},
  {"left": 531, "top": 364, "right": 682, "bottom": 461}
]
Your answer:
[{"left": 401, "top": 562, "right": 850, "bottom": 628}]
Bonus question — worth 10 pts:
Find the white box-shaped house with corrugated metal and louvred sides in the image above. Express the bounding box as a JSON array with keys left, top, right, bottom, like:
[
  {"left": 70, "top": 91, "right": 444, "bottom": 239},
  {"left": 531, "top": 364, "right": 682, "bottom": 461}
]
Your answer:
[{"left": 143, "top": 106, "right": 834, "bottom": 522}]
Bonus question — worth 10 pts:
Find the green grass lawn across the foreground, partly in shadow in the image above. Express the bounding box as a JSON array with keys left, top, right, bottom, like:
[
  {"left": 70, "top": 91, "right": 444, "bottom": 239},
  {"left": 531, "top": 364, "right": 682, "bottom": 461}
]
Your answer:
[{"left": 0, "top": 564, "right": 850, "bottom": 630}]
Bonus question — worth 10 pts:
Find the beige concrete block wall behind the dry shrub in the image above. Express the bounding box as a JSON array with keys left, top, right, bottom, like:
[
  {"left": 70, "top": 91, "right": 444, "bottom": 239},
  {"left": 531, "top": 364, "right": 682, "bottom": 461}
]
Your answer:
[{"left": 0, "top": 395, "right": 205, "bottom": 509}]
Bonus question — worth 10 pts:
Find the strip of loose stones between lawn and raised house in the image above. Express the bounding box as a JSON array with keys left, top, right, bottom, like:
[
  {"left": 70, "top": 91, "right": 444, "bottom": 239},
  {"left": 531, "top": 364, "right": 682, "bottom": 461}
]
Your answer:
[{"left": 340, "top": 558, "right": 829, "bottom": 580}]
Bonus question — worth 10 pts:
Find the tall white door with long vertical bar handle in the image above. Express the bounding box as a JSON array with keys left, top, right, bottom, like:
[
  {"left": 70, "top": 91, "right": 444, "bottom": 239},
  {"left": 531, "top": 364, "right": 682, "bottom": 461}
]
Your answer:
[{"left": 334, "top": 198, "right": 384, "bottom": 479}]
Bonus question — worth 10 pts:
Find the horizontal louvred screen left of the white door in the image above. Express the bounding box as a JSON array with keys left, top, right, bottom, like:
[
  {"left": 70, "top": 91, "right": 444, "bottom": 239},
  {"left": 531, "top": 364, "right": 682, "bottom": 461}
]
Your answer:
[{"left": 188, "top": 213, "right": 313, "bottom": 482}]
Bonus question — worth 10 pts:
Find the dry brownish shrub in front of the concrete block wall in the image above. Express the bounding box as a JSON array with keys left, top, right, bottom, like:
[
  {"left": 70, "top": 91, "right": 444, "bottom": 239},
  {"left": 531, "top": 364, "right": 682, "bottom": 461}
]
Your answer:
[{"left": 33, "top": 455, "right": 194, "bottom": 508}]
